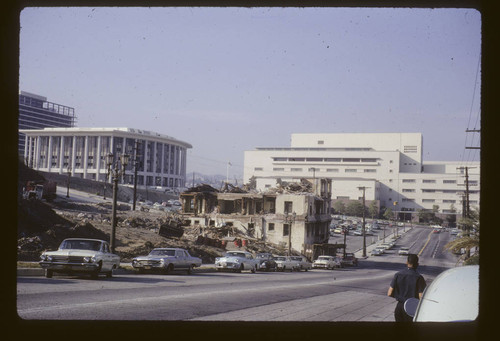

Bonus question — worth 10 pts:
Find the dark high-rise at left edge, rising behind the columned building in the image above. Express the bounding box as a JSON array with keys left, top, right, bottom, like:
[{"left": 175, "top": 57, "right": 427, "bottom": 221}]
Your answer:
[{"left": 18, "top": 91, "right": 76, "bottom": 155}]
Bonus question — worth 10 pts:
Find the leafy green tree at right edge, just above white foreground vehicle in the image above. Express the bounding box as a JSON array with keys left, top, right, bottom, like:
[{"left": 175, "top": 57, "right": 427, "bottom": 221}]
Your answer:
[{"left": 444, "top": 209, "right": 479, "bottom": 265}]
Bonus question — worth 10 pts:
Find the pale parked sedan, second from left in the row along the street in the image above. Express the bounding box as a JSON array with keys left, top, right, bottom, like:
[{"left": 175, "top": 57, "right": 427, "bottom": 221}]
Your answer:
[{"left": 132, "top": 248, "right": 201, "bottom": 274}]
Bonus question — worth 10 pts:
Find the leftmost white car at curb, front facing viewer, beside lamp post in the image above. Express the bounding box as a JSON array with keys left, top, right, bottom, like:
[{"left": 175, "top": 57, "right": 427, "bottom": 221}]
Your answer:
[{"left": 39, "top": 238, "right": 120, "bottom": 279}]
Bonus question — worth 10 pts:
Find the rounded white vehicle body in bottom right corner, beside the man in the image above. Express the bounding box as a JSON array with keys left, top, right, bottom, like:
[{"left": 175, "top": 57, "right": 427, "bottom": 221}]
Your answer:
[{"left": 414, "top": 265, "right": 479, "bottom": 322}]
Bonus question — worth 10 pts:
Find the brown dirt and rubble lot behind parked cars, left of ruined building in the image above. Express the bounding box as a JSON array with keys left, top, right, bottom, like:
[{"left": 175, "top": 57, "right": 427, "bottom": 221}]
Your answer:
[{"left": 17, "top": 163, "right": 285, "bottom": 263}]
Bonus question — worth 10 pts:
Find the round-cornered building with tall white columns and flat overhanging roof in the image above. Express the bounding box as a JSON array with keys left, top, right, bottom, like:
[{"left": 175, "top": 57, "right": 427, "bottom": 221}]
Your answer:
[{"left": 19, "top": 128, "right": 192, "bottom": 188}]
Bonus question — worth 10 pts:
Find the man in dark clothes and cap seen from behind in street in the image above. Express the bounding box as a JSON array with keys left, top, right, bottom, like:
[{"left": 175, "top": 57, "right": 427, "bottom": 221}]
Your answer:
[{"left": 387, "top": 254, "right": 426, "bottom": 322}]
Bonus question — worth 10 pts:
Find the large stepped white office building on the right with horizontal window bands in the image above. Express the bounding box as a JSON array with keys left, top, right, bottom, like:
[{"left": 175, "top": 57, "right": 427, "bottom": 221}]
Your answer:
[{"left": 244, "top": 133, "right": 480, "bottom": 220}]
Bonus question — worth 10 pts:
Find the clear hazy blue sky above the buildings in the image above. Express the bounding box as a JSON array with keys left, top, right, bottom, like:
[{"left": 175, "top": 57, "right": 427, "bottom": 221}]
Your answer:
[{"left": 19, "top": 7, "right": 481, "bottom": 179}]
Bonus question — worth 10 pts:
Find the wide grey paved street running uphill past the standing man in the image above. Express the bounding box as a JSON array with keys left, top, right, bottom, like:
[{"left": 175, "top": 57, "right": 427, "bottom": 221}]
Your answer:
[{"left": 17, "top": 227, "right": 456, "bottom": 321}]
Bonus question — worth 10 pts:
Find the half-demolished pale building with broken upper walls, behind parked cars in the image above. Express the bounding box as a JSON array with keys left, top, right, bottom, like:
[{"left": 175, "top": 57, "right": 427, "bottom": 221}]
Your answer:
[{"left": 180, "top": 179, "right": 332, "bottom": 257}]
